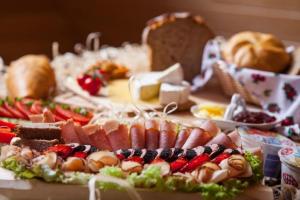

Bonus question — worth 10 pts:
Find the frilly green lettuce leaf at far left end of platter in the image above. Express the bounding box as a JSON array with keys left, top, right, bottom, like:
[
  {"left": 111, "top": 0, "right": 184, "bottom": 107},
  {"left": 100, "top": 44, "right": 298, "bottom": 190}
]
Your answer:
[{"left": 1, "top": 156, "right": 35, "bottom": 179}]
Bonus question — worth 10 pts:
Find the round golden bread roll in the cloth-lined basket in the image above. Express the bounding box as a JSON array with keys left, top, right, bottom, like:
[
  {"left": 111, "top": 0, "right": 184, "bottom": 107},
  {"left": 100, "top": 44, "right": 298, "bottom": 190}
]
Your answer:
[{"left": 222, "top": 31, "right": 291, "bottom": 73}]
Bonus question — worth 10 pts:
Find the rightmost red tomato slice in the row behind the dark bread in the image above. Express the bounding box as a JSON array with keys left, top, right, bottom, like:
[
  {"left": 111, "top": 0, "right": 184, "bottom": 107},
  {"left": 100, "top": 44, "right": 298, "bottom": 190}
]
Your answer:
[{"left": 55, "top": 105, "right": 91, "bottom": 124}]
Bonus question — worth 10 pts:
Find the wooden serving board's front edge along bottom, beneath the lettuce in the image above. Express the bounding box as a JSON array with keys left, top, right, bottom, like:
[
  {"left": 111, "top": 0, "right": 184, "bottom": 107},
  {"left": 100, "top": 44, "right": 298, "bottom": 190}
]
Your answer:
[{"left": 0, "top": 180, "right": 273, "bottom": 200}]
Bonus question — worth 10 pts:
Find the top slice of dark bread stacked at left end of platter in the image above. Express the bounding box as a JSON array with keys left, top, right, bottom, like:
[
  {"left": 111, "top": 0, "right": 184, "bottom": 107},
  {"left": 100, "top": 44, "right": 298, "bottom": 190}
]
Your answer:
[{"left": 17, "top": 123, "right": 61, "bottom": 141}]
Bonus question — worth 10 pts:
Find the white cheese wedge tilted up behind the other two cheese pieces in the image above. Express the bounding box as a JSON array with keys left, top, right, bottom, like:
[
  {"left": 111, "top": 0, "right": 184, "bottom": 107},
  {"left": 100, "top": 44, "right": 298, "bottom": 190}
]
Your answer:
[{"left": 158, "top": 63, "right": 184, "bottom": 85}]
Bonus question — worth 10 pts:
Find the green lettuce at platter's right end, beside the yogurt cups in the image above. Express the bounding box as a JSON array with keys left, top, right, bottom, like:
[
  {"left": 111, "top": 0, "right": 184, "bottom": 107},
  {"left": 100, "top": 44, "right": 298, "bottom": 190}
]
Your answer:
[{"left": 244, "top": 151, "right": 263, "bottom": 182}]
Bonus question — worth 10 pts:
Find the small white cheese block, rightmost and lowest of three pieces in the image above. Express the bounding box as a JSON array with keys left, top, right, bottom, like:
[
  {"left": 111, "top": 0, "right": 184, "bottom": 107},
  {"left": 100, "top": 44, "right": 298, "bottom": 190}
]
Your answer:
[{"left": 159, "top": 81, "right": 190, "bottom": 105}]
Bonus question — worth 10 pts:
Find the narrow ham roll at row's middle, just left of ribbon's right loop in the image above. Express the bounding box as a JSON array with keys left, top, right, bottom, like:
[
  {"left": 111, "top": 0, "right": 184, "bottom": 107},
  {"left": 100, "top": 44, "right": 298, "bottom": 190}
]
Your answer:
[{"left": 145, "top": 119, "right": 160, "bottom": 150}]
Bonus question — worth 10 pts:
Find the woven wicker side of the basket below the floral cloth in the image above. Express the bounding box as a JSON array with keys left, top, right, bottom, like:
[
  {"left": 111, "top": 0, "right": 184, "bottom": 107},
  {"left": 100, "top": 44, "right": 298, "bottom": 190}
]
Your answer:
[{"left": 213, "top": 62, "right": 260, "bottom": 105}]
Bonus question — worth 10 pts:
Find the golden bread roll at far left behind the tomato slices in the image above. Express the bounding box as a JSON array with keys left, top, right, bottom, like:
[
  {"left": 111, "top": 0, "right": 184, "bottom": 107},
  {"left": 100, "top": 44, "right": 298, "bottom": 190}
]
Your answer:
[{"left": 6, "top": 55, "right": 56, "bottom": 99}]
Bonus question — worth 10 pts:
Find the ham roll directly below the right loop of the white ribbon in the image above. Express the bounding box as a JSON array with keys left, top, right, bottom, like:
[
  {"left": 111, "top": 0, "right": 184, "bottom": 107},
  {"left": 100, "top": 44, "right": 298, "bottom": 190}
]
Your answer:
[{"left": 159, "top": 120, "right": 177, "bottom": 148}]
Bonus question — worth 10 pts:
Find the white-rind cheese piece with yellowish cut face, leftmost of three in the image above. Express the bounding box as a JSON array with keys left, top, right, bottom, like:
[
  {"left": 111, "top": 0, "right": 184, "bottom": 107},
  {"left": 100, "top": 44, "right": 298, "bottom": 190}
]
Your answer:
[{"left": 132, "top": 73, "right": 160, "bottom": 101}]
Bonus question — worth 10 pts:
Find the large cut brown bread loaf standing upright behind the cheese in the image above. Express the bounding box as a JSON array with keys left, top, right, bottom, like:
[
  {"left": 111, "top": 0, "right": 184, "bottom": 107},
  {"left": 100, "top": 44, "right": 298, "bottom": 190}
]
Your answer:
[{"left": 142, "top": 13, "right": 214, "bottom": 81}]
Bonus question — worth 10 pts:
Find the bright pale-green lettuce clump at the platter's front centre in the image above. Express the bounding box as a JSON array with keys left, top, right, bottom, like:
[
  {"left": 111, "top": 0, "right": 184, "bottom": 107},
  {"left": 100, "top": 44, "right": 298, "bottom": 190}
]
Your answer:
[{"left": 127, "top": 166, "right": 164, "bottom": 190}]
